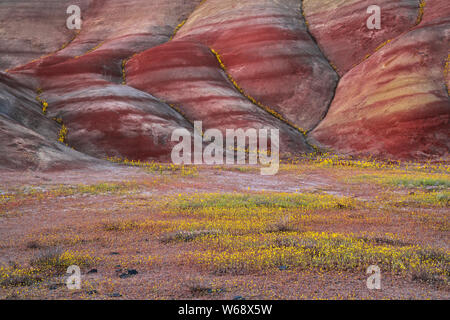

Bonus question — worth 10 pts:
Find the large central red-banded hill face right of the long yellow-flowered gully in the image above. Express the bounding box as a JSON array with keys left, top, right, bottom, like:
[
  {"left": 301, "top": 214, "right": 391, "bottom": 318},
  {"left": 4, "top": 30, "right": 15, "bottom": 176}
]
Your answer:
[{"left": 175, "top": 0, "right": 338, "bottom": 130}]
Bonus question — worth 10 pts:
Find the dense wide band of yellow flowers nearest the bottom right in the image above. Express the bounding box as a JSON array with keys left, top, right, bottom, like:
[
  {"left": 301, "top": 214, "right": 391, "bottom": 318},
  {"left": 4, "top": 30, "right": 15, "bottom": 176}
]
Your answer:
[{"left": 184, "top": 232, "right": 450, "bottom": 281}]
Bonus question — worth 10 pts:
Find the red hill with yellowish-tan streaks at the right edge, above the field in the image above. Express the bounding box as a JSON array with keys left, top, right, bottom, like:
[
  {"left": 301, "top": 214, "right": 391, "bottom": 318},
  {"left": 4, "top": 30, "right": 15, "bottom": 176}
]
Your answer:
[{"left": 312, "top": 0, "right": 450, "bottom": 159}]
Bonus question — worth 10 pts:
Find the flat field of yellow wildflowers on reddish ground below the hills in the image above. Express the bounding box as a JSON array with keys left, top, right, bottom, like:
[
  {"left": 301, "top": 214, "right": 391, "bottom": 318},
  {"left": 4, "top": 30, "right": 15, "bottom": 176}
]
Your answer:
[{"left": 0, "top": 155, "right": 450, "bottom": 299}]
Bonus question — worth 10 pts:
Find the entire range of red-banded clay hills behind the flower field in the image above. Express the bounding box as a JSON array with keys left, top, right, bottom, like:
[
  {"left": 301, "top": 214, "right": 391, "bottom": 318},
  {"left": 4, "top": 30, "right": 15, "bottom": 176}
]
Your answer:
[{"left": 0, "top": 0, "right": 450, "bottom": 168}]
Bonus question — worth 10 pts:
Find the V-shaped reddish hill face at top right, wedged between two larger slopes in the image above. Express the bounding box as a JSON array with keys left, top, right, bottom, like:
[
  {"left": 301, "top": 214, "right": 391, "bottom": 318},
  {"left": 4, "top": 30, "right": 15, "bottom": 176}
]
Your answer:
[{"left": 303, "top": 0, "right": 420, "bottom": 75}]
